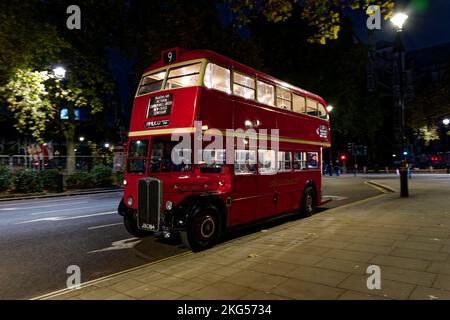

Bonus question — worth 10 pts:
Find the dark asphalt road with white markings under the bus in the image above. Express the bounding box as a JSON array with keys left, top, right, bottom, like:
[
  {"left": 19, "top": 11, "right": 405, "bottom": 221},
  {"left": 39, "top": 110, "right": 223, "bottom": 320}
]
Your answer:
[{"left": 0, "top": 176, "right": 386, "bottom": 299}]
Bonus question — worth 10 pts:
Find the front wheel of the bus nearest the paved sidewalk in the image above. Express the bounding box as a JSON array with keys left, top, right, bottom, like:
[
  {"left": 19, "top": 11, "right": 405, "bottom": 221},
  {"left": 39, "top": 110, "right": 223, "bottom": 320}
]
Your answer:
[{"left": 180, "top": 204, "right": 221, "bottom": 252}]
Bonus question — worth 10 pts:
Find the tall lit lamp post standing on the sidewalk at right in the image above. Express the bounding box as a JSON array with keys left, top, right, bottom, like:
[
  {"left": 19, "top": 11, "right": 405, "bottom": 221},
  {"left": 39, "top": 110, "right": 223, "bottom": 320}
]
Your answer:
[{"left": 391, "top": 12, "right": 408, "bottom": 197}]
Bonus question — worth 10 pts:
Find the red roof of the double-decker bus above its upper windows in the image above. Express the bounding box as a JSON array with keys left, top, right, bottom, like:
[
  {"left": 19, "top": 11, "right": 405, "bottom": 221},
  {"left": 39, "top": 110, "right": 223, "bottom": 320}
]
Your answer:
[{"left": 144, "top": 48, "right": 326, "bottom": 106}]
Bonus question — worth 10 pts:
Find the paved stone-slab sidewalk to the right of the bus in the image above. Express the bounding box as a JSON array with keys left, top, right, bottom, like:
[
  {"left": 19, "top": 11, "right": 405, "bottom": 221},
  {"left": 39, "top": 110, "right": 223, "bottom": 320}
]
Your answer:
[{"left": 40, "top": 180, "right": 450, "bottom": 300}]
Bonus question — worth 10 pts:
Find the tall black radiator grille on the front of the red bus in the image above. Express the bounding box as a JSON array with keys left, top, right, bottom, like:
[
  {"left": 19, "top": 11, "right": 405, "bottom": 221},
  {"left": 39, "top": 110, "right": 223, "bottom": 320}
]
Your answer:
[{"left": 137, "top": 178, "right": 162, "bottom": 232}]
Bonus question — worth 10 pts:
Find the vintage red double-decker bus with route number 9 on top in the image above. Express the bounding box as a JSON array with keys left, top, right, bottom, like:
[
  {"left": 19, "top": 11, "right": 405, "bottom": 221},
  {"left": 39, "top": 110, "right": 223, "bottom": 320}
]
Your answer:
[{"left": 118, "top": 48, "right": 330, "bottom": 250}]
